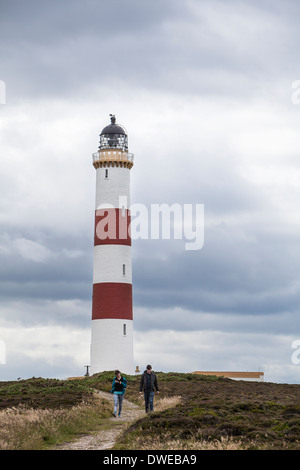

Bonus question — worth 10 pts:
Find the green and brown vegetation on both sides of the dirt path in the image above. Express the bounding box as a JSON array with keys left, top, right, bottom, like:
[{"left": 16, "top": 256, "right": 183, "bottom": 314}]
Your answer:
[{"left": 0, "top": 371, "right": 300, "bottom": 450}]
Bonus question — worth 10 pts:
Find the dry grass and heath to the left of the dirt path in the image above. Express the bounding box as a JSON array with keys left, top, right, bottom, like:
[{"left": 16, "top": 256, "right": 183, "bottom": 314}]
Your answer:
[{"left": 0, "top": 378, "right": 111, "bottom": 450}]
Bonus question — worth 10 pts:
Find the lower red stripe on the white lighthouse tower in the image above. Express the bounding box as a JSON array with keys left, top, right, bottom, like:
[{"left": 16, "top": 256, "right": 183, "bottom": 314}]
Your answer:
[{"left": 92, "top": 282, "right": 133, "bottom": 320}]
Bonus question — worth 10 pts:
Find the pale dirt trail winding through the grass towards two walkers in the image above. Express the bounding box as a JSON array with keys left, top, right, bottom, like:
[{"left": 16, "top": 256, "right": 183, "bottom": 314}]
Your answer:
[{"left": 55, "top": 391, "right": 145, "bottom": 450}]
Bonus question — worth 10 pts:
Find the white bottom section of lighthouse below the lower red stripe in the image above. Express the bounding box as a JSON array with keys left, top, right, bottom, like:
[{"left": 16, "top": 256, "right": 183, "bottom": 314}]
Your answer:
[{"left": 91, "top": 318, "right": 134, "bottom": 375}]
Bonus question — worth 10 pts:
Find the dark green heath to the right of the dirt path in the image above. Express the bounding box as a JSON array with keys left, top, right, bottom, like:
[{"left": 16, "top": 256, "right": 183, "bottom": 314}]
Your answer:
[{"left": 113, "top": 374, "right": 300, "bottom": 449}]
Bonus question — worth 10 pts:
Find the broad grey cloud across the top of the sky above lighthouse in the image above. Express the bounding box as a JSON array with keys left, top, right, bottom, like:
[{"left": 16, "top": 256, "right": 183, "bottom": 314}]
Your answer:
[{"left": 0, "top": 0, "right": 299, "bottom": 99}]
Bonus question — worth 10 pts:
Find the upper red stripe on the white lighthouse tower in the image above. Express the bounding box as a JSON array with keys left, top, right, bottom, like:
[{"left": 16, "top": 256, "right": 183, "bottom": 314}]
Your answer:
[{"left": 94, "top": 208, "right": 131, "bottom": 246}]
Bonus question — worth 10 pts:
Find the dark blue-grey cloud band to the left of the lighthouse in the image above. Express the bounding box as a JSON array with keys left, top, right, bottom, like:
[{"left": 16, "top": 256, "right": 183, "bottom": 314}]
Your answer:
[{"left": 0, "top": 233, "right": 92, "bottom": 300}]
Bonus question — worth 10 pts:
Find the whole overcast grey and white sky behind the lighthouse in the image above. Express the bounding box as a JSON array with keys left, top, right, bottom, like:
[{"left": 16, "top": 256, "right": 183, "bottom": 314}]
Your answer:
[{"left": 0, "top": 0, "right": 300, "bottom": 383}]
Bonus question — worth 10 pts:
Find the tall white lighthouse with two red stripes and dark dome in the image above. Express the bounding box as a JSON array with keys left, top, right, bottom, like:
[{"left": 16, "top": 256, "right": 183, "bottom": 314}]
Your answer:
[{"left": 91, "top": 114, "right": 134, "bottom": 374}]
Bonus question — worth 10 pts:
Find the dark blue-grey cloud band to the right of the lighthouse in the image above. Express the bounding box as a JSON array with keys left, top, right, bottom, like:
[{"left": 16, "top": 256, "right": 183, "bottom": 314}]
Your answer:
[{"left": 134, "top": 222, "right": 300, "bottom": 315}]
